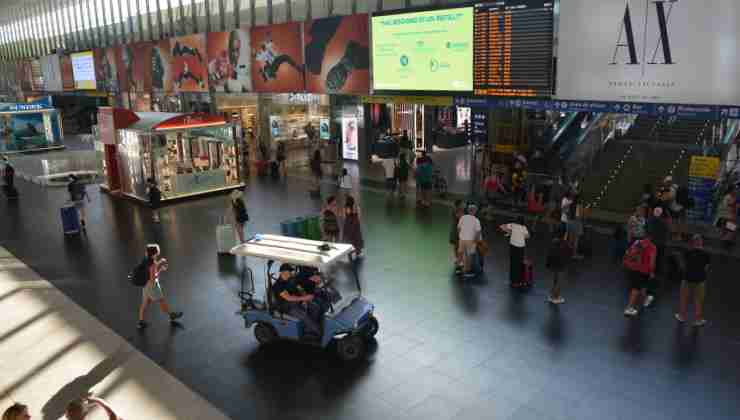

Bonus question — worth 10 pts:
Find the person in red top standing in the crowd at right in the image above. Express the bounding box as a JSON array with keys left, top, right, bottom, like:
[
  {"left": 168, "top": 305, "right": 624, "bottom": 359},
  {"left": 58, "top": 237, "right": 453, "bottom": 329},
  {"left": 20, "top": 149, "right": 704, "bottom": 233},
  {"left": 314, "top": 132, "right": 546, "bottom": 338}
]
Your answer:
[{"left": 624, "top": 232, "right": 658, "bottom": 317}]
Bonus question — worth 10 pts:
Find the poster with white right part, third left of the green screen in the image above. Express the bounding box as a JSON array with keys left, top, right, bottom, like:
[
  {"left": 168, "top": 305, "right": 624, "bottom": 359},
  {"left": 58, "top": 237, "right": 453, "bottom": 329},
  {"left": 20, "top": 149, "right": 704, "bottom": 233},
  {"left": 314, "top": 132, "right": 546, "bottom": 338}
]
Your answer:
[{"left": 207, "top": 29, "right": 252, "bottom": 93}]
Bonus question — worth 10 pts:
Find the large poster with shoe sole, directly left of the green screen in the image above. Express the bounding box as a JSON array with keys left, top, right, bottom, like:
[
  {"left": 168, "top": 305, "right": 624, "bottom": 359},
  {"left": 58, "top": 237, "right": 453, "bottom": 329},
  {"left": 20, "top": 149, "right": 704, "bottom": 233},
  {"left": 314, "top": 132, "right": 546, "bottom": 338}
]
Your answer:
[{"left": 303, "top": 14, "right": 370, "bottom": 95}]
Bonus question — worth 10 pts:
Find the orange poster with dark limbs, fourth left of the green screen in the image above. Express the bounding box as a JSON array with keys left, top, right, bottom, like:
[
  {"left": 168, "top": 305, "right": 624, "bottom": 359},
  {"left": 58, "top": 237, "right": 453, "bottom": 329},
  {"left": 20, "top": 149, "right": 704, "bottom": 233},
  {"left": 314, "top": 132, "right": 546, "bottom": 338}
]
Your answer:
[{"left": 170, "top": 34, "right": 208, "bottom": 92}]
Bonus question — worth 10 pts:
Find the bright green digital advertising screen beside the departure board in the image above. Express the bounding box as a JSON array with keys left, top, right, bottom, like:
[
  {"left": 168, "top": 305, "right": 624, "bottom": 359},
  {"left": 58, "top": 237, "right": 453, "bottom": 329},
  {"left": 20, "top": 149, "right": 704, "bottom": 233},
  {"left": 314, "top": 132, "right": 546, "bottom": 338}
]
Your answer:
[{"left": 372, "top": 7, "right": 473, "bottom": 92}]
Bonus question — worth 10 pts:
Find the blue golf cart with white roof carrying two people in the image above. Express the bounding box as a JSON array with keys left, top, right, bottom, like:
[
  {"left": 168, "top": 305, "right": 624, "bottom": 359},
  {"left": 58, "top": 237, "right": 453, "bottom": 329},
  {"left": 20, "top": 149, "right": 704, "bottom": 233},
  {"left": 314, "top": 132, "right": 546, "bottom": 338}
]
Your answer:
[{"left": 231, "top": 235, "right": 379, "bottom": 361}]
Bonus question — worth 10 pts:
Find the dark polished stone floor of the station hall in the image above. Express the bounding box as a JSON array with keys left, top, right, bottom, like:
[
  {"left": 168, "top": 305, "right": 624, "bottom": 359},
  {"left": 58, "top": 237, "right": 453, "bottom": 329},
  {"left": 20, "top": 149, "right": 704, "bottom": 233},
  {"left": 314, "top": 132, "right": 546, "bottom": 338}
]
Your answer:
[{"left": 0, "top": 176, "right": 740, "bottom": 420}]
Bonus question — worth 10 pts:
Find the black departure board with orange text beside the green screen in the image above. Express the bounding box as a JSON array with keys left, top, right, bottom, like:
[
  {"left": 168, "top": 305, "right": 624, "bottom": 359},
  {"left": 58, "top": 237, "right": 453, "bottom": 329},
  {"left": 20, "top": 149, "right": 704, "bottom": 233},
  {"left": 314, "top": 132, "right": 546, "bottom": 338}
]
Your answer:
[{"left": 473, "top": 0, "right": 554, "bottom": 97}]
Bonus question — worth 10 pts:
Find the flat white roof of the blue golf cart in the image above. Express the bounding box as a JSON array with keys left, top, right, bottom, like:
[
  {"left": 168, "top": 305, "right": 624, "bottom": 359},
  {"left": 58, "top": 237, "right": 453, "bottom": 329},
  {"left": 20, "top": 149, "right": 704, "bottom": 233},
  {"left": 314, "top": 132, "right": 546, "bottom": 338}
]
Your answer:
[{"left": 231, "top": 235, "right": 354, "bottom": 268}]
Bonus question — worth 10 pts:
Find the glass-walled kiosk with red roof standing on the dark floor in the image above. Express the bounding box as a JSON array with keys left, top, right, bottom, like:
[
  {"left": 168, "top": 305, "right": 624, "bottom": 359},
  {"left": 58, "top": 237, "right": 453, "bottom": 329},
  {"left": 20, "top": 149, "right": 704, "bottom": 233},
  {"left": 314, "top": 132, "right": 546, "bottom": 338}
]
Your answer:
[{"left": 99, "top": 109, "right": 244, "bottom": 201}]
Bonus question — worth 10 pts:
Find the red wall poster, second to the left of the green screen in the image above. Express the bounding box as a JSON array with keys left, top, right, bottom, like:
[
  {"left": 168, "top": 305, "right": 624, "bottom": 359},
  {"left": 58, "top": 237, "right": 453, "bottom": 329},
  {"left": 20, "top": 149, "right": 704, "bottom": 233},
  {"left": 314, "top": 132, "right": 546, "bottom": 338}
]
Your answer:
[{"left": 251, "top": 22, "right": 306, "bottom": 93}]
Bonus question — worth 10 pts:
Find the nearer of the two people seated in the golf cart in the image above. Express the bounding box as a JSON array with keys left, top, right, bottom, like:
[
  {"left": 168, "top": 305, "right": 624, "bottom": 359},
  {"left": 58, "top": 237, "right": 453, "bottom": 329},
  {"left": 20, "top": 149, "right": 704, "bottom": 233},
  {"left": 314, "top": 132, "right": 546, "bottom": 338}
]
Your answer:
[{"left": 272, "top": 264, "right": 321, "bottom": 337}]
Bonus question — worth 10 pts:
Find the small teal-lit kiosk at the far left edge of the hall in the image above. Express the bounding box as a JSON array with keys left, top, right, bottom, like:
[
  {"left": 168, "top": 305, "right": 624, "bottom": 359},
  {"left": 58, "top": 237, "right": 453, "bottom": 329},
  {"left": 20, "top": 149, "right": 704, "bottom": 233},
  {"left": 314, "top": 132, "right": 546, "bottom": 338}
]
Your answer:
[{"left": 0, "top": 98, "right": 64, "bottom": 153}]
